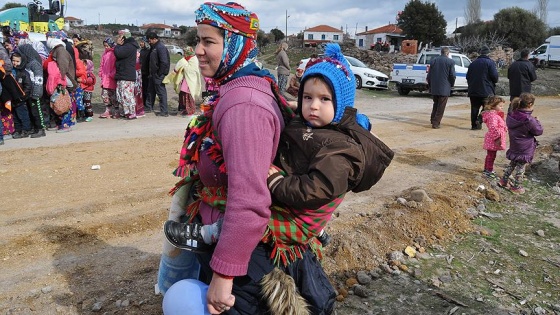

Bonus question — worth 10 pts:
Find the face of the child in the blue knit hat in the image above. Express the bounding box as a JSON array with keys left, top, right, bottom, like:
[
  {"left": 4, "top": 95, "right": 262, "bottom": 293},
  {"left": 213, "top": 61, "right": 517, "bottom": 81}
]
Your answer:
[{"left": 301, "top": 78, "right": 334, "bottom": 127}]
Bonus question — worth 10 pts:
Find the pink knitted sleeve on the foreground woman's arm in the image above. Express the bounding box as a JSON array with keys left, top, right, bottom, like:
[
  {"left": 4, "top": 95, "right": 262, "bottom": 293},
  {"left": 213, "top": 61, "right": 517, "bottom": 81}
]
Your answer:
[{"left": 210, "top": 102, "right": 279, "bottom": 276}]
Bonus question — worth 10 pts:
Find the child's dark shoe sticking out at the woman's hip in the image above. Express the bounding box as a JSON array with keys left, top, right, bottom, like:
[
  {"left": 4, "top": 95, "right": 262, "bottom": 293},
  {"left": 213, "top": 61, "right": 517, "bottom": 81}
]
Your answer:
[{"left": 163, "top": 220, "right": 213, "bottom": 253}]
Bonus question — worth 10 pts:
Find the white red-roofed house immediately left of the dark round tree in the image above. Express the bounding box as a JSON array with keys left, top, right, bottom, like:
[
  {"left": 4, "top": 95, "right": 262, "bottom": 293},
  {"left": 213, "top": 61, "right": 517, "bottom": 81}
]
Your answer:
[{"left": 356, "top": 24, "right": 405, "bottom": 51}]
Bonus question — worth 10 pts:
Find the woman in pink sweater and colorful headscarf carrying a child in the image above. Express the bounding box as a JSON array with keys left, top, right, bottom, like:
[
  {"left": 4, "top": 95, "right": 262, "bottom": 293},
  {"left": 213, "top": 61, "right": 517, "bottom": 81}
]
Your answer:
[{"left": 163, "top": 2, "right": 335, "bottom": 315}]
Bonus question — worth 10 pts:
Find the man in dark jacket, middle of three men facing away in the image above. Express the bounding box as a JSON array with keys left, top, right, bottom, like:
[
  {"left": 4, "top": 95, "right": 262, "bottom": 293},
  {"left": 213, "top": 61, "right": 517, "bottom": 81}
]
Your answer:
[{"left": 467, "top": 45, "right": 498, "bottom": 130}]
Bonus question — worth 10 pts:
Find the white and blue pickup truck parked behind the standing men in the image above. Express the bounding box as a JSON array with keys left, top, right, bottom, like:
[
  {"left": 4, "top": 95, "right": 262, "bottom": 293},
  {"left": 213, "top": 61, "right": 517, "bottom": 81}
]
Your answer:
[{"left": 389, "top": 49, "right": 471, "bottom": 95}]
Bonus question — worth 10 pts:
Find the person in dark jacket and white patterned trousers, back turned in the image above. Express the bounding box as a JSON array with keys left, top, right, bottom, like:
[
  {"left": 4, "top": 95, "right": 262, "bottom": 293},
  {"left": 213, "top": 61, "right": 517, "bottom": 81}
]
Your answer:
[{"left": 114, "top": 30, "right": 140, "bottom": 120}]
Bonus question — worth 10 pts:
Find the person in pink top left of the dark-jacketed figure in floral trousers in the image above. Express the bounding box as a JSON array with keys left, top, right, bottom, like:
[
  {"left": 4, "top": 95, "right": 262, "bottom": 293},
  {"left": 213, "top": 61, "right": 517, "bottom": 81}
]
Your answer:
[{"left": 99, "top": 37, "right": 118, "bottom": 118}]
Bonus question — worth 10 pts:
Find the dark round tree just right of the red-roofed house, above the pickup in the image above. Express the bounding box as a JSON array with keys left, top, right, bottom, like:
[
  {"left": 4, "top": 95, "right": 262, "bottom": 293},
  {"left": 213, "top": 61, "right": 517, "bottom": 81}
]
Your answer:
[{"left": 397, "top": 0, "right": 447, "bottom": 45}]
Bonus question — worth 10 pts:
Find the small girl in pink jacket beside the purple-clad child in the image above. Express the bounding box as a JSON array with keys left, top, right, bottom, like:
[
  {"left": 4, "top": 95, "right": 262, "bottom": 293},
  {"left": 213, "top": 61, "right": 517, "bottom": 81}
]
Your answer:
[{"left": 482, "top": 96, "right": 507, "bottom": 179}]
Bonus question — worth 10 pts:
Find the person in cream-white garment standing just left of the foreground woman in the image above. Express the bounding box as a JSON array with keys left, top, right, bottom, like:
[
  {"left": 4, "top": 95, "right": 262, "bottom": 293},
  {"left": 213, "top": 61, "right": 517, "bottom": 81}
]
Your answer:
[{"left": 173, "top": 47, "right": 202, "bottom": 117}]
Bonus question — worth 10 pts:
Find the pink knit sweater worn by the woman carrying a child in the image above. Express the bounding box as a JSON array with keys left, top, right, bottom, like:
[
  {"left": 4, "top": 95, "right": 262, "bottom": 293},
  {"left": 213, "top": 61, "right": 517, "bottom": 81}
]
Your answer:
[{"left": 198, "top": 76, "right": 284, "bottom": 276}]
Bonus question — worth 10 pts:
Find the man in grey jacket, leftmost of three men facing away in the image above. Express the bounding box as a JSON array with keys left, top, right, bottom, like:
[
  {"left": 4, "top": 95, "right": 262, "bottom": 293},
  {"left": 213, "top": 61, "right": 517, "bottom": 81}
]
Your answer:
[{"left": 427, "top": 47, "right": 456, "bottom": 129}]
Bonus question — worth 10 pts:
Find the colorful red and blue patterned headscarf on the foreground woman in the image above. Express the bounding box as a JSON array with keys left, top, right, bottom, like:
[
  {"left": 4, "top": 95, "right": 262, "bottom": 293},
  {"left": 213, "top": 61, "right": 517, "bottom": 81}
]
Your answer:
[{"left": 195, "top": 2, "right": 259, "bottom": 85}]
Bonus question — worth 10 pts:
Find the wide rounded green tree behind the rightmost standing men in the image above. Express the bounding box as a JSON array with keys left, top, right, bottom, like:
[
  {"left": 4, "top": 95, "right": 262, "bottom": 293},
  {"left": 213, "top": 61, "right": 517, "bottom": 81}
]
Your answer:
[{"left": 492, "top": 7, "right": 547, "bottom": 50}]
